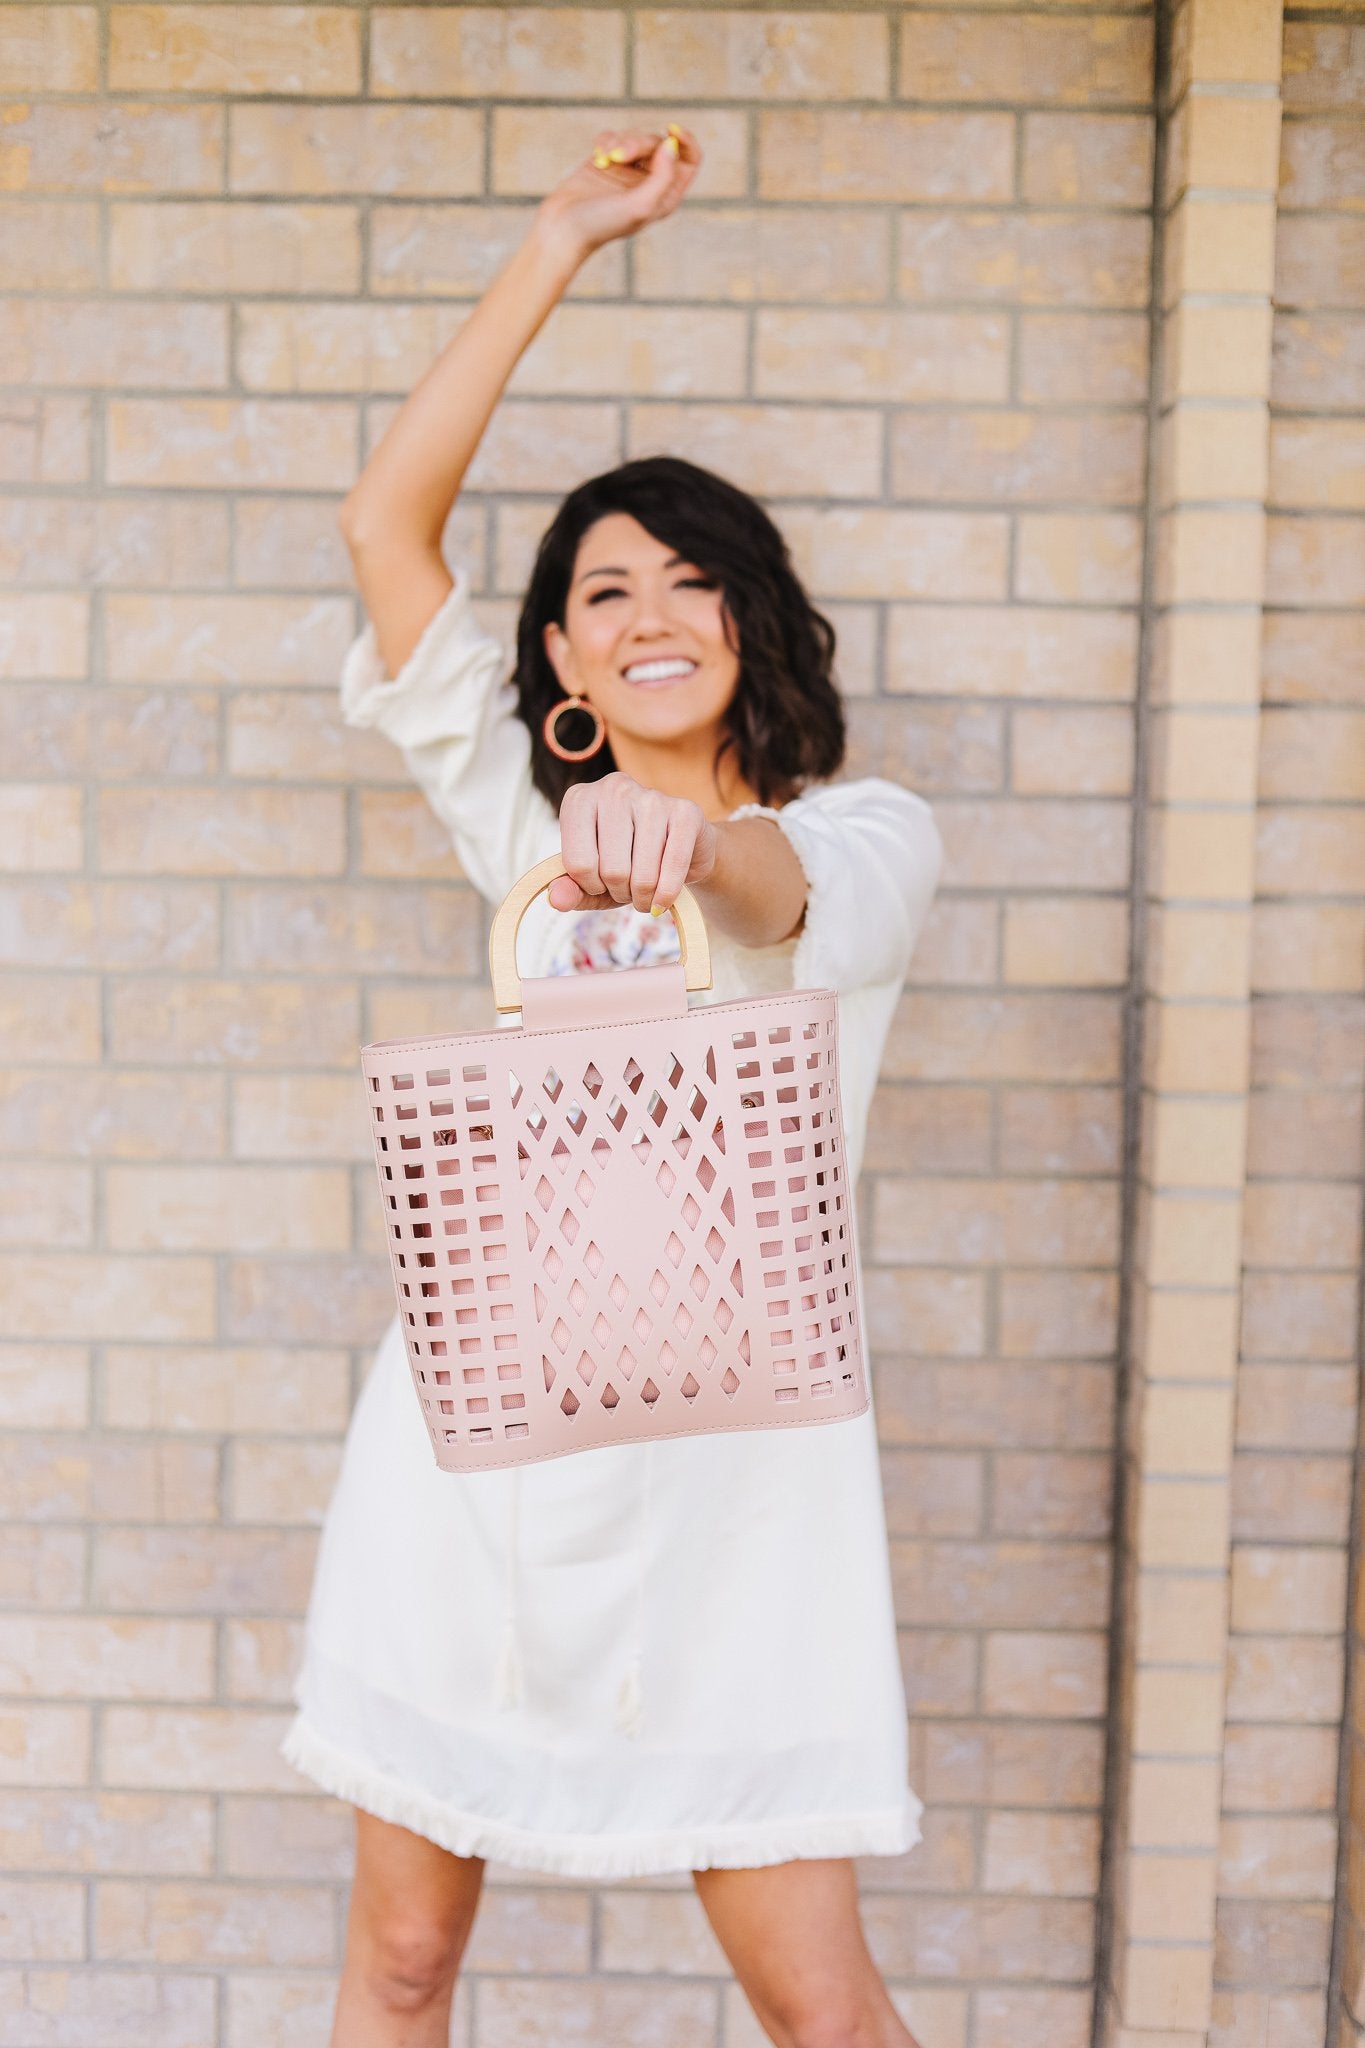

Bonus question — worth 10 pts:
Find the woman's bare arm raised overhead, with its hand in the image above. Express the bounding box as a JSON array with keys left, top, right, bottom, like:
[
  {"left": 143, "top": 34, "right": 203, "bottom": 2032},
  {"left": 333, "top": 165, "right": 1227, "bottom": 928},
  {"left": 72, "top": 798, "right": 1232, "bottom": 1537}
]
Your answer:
[{"left": 340, "top": 129, "right": 700, "bottom": 676}]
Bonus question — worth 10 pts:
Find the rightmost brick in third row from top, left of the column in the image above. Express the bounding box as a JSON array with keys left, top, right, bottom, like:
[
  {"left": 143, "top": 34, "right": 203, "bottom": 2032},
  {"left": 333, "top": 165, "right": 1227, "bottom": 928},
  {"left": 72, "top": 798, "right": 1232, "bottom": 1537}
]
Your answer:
[{"left": 896, "top": 209, "right": 1150, "bottom": 309}]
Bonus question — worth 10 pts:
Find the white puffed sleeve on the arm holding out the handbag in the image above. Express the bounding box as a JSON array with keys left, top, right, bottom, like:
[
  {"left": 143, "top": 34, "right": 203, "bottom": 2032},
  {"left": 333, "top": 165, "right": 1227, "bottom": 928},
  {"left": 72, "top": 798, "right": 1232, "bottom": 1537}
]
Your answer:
[{"left": 731, "top": 776, "right": 943, "bottom": 991}]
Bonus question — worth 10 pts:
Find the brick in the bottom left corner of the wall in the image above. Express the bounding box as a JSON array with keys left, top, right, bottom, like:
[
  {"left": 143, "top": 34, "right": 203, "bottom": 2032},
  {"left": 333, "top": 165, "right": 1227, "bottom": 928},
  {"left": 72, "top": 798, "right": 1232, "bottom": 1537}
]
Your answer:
[{"left": 0, "top": 1968, "right": 215, "bottom": 2048}]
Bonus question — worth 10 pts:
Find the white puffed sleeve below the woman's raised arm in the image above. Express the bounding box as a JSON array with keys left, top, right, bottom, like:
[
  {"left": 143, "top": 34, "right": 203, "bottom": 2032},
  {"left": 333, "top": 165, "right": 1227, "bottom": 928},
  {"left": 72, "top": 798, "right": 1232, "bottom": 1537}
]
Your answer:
[{"left": 342, "top": 567, "right": 559, "bottom": 903}]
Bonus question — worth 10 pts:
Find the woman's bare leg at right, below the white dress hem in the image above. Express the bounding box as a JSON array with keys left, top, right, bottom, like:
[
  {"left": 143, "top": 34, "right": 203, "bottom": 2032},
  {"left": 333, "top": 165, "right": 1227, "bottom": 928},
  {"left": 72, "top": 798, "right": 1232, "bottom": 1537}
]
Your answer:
[{"left": 692, "top": 1858, "right": 919, "bottom": 2048}]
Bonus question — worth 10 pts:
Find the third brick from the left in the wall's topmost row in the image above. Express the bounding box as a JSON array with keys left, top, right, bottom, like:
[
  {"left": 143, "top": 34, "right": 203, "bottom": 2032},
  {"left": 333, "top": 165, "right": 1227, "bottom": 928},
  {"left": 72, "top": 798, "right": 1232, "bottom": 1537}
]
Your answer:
[{"left": 370, "top": 6, "right": 624, "bottom": 98}]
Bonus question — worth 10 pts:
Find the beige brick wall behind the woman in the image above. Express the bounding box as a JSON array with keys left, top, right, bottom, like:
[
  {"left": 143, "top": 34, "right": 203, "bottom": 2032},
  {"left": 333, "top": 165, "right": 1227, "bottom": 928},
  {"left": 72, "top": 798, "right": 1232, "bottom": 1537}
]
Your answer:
[{"left": 0, "top": 12, "right": 1365, "bottom": 2048}]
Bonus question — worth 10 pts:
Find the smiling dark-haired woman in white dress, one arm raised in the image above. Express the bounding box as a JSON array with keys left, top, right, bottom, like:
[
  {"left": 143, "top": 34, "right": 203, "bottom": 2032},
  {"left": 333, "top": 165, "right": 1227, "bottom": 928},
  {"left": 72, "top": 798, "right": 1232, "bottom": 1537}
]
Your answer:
[{"left": 284, "top": 129, "right": 941, "bottom": 2048}]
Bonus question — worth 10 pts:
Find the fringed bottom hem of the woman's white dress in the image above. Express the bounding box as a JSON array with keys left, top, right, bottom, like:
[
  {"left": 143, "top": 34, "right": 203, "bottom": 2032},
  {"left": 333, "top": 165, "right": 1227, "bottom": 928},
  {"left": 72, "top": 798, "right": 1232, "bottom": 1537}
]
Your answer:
[{"left": 280, "top": 1714, "right": 925, "bottom": 1878}]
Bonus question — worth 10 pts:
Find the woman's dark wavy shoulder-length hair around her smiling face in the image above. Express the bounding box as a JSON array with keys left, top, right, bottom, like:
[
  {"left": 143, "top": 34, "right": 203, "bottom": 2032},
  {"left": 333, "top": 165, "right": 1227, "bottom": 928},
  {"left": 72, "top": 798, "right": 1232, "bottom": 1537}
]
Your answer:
[{"left": 512, "top": 455, "right": 845, "bottom": 809}]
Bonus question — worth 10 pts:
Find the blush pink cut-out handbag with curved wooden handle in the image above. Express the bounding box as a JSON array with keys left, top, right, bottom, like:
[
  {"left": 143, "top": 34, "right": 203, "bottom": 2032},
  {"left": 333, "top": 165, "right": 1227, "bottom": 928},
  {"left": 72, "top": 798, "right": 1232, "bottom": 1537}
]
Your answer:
[{"left": 360, "top": 854, "right": 868, "bottom": 1473}]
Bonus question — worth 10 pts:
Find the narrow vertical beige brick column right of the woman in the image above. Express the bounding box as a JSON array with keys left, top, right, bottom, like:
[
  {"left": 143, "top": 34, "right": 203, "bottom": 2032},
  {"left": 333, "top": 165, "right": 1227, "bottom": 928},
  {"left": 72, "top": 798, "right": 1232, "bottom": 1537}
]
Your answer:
[{"left": 1099, "top": 0, "right": 1281, "bottom": 2048}]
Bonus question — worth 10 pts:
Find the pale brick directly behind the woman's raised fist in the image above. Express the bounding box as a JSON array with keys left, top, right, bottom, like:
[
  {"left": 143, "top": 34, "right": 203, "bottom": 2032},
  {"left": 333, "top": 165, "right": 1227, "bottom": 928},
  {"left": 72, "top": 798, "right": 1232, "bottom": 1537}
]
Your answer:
[{"left": 491, "top": 104, "right": 749, "bottom": 201}]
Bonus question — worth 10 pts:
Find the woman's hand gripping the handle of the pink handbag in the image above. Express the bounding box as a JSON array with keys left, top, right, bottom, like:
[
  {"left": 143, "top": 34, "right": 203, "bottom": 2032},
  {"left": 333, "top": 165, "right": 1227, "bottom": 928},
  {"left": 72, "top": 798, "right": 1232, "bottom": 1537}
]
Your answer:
[{"left": 548, "top": 770, "right": 716, "bottom": 909}]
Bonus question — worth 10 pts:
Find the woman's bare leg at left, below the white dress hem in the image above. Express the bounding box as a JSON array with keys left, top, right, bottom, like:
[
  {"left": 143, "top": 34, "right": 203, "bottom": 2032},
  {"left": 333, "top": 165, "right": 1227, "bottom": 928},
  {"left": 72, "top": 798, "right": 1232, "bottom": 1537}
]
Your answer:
[{"left": 332, "top": 1808, "right": 483, "bottom": 2048}]
